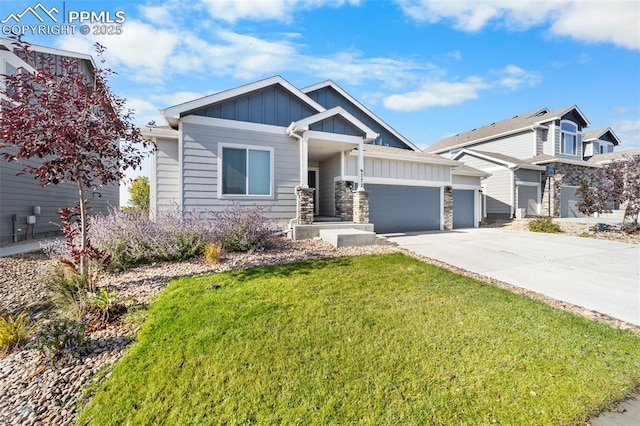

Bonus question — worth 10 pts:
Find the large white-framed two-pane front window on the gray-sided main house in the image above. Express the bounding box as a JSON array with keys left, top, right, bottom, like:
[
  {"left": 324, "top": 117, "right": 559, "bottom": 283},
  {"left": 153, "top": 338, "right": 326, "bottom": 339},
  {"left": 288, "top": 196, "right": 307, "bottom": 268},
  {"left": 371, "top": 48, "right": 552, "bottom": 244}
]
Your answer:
[{"left": 219, "top": 144, "right": 273, "bottom": 196}]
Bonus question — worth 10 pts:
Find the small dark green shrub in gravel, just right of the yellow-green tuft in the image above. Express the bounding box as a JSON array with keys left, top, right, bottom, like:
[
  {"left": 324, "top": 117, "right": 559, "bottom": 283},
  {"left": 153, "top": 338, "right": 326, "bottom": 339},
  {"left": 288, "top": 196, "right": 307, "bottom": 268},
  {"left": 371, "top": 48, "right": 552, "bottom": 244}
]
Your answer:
[{"left": 38, "top": 321, "right": 90, "bottom": 362}]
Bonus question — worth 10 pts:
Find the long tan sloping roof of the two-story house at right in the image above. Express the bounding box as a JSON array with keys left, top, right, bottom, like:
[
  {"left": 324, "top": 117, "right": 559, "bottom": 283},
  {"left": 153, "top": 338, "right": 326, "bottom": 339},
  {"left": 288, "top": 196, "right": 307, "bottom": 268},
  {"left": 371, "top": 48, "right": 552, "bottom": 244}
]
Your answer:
[{"left": 426, "top": 105, "right": 589, "bottom": 153}]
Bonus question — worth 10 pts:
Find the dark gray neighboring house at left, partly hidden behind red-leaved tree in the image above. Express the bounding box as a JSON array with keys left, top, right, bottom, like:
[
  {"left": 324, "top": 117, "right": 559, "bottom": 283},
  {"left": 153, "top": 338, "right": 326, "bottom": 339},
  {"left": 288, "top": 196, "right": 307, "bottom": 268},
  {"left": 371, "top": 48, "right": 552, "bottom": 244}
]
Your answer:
[{"left": 0, "top": 38, "right": 119, "bottom": 245}]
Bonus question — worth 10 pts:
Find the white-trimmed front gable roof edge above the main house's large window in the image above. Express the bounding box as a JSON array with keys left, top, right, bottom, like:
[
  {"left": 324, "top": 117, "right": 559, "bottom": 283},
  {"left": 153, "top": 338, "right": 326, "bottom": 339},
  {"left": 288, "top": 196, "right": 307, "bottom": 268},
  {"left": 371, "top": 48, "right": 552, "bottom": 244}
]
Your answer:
[{"left": 160, "top": 75, "right": 325, "bottom": 128}]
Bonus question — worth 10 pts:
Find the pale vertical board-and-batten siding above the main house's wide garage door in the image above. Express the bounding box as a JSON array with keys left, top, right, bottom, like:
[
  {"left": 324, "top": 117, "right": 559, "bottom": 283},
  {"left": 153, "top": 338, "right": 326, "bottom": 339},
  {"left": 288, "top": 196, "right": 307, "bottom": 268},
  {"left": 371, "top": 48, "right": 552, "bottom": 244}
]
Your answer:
[{"left": 345, "top": 155, "right": 451, "bottom": 186}]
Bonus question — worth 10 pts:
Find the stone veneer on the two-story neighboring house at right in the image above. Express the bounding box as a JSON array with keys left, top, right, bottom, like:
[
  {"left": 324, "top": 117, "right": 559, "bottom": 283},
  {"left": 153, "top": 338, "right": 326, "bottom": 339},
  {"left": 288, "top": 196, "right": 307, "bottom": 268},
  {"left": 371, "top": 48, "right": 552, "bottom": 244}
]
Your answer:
[{"left": 542, "top": 163, "right": 597, "bottom": 217}]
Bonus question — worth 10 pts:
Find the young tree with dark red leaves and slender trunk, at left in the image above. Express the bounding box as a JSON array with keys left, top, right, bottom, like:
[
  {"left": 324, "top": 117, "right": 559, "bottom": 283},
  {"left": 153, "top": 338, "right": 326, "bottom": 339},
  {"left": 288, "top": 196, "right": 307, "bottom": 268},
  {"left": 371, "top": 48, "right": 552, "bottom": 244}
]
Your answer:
[{"left": 0, "top": 38, "right": 149, "bottom": 275}]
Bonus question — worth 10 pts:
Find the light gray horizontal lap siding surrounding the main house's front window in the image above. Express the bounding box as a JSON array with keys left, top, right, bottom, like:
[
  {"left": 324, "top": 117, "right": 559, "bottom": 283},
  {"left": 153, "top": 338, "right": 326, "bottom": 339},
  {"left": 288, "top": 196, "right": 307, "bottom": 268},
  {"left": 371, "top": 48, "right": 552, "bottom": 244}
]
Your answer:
[{"left": 181, "top": 122, "right": 300, "bottom": 224}]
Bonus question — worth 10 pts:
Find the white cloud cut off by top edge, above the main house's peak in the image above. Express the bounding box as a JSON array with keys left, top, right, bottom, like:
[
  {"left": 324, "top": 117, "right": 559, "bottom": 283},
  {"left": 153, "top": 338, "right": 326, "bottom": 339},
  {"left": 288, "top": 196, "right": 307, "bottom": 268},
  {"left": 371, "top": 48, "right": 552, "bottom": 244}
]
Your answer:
[{"left": 202, "top": 0, "right": 360, "bottom": 22}]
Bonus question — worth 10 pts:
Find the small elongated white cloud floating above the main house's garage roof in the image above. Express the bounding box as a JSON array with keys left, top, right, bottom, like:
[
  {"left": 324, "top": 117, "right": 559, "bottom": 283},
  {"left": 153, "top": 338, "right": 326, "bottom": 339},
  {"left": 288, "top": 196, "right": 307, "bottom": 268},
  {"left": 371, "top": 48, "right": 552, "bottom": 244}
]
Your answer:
[{"left": 384, "top": 77, "right": 491, "bottom": 111}]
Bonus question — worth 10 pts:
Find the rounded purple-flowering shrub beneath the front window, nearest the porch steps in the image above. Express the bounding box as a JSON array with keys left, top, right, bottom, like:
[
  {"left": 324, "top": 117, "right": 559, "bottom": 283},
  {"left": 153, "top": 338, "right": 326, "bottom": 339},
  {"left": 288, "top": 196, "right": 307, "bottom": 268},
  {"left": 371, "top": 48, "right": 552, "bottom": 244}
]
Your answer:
[{"left": 212, "top": 204, "right": 279, "bottom": 252}]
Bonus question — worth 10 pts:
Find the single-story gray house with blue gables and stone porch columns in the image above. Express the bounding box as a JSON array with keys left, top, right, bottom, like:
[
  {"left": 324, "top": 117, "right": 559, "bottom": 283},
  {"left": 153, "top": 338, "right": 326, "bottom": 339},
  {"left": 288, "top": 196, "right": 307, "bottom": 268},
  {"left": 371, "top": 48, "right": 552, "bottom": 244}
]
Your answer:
[{"left": 143, "top": 76, "right": 487, "bottom": 238}]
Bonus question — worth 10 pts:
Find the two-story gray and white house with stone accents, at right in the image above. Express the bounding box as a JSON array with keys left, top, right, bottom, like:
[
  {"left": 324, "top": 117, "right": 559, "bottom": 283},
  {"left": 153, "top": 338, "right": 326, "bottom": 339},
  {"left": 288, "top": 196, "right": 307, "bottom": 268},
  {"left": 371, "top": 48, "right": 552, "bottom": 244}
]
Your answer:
[{"left": 426, "top": 105, "right": 620, "bottom": 218}]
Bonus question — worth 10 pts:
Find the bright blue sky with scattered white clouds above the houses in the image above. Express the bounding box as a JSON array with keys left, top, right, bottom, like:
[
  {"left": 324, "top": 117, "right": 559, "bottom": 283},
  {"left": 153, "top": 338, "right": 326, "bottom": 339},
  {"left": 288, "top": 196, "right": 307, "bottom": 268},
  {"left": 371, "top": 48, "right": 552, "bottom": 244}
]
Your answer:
[{"left": 0, "top": 0, "right": 640, "bottom": 203}]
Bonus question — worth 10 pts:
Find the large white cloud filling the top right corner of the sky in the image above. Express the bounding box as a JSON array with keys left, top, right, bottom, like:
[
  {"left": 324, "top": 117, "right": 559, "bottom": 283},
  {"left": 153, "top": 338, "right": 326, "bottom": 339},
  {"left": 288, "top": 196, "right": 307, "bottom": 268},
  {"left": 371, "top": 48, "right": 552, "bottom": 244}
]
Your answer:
[{"left": 396, "top": 0, "right": 640, "bottom": 49}]
